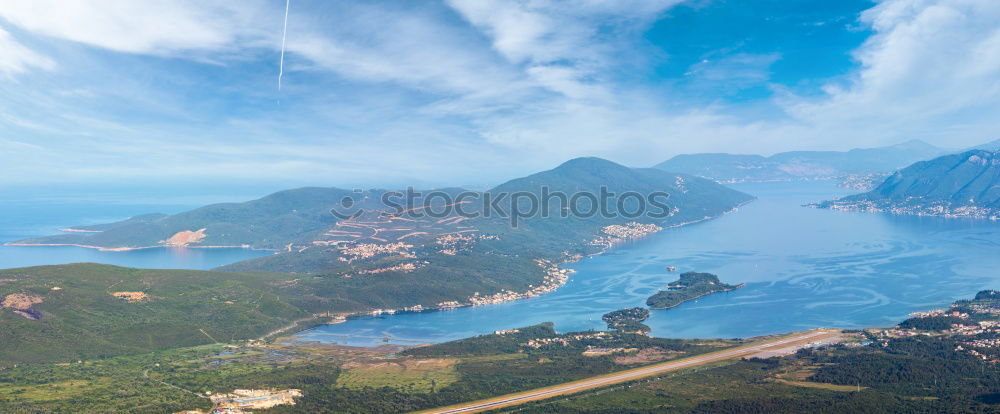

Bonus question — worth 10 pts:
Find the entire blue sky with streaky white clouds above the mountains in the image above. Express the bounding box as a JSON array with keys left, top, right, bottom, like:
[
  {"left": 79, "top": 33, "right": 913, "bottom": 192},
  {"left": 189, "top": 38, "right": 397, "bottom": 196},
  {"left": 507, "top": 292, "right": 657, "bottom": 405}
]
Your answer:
[{"left": 0, "top": 0, "right": 1000, "bottom": 187}]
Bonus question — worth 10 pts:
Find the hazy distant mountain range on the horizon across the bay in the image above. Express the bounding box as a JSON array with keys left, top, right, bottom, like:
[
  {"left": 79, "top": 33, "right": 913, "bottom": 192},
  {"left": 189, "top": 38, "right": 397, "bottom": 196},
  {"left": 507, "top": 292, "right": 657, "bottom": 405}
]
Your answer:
[{"left": 654, "top": 140, "right": 949, "bottom": 183}]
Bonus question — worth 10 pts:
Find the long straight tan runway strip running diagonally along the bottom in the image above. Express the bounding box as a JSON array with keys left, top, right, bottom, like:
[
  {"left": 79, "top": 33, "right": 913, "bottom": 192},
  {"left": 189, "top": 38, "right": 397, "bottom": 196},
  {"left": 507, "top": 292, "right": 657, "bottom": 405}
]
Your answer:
[{"left": 423, "top": 329, "right": 840, "bottom": 414}]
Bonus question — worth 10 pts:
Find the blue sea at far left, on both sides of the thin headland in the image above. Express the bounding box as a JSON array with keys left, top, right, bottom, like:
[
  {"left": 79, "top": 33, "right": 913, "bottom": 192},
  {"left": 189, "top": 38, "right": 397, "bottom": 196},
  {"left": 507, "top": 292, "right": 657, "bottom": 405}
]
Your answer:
[{"left": 0, "top": 198, "right": 270, "bottom": 270}]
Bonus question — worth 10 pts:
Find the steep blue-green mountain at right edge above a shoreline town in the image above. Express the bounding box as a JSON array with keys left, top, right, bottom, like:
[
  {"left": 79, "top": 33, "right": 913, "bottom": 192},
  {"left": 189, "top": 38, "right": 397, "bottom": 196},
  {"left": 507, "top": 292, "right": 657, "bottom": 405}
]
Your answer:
[{"left": 816, "top": 150, "right": 1000, "bottom": 219}]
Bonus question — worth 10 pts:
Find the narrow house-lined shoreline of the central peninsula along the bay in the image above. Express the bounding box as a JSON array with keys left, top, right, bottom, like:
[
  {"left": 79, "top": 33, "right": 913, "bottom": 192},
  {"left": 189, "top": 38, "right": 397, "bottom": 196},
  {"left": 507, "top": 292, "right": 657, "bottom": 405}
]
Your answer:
[{"left": 289, "top": 197, "right": 757, "bottom": 336}]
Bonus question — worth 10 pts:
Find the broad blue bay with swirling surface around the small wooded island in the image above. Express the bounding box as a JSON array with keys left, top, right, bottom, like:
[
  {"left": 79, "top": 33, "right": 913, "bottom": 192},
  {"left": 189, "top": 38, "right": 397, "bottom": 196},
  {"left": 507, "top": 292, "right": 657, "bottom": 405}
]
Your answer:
[{"left": 299, "top": 182, "right": 1000, "bottom": 346}]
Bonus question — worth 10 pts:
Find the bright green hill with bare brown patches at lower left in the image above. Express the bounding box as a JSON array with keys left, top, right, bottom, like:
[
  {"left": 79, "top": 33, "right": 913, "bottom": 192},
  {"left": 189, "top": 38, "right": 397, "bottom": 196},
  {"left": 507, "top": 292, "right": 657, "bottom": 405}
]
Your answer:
[{"left": 0, "top": 264, "right": 309, "bottom": 362}]
